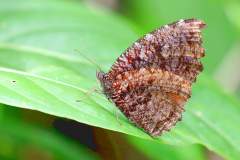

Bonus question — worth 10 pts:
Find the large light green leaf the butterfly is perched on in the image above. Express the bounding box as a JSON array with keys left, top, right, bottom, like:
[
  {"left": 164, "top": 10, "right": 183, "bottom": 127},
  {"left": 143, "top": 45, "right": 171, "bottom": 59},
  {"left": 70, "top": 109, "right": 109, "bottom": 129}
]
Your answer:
[{"left": 0, "top": 0, "right": 240, "bottom": 159}]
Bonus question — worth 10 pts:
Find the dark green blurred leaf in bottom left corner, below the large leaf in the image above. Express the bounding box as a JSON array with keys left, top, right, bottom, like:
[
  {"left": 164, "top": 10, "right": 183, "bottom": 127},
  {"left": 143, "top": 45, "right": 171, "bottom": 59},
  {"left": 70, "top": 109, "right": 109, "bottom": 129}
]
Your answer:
[{"left": 0, "top": 105, "right": 99, "bottom": 160}]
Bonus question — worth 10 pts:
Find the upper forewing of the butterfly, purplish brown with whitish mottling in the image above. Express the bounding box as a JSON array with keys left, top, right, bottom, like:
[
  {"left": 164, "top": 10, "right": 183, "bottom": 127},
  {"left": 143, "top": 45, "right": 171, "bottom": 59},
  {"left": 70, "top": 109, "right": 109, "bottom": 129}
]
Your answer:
[{"left": 109, "top": 19, "right": 205, "bottom": 82}]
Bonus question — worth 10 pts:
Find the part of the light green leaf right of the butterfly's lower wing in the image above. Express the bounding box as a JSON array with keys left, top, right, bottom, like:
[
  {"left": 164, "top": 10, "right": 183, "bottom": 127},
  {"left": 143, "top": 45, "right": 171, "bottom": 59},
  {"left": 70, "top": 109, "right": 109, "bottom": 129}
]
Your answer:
[{"left": 162, "top": 75, "right": 240, "bottom": 159}]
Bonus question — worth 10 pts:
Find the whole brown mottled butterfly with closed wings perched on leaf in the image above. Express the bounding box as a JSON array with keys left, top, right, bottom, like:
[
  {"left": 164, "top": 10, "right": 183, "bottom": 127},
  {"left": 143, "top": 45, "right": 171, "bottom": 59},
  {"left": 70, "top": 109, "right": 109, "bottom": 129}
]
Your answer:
[{"left": 97, "top": 19, "right": 206, "bottom": 137}]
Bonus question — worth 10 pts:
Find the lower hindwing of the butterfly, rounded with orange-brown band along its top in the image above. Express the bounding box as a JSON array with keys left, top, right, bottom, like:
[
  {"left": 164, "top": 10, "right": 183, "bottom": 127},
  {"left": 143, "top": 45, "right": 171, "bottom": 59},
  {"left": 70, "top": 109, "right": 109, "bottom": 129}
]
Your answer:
[{"left": 109, "top": 68, "right": 191, "bottom": 136}]
